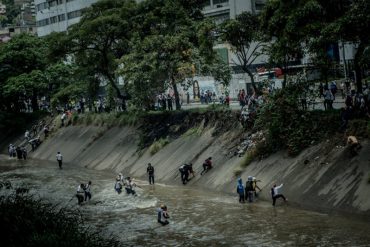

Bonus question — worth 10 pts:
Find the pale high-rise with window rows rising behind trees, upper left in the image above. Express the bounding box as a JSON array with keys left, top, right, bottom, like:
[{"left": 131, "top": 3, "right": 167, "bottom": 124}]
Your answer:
[{"left": 35, "top": 0, "right": 98, "bottom": 36}]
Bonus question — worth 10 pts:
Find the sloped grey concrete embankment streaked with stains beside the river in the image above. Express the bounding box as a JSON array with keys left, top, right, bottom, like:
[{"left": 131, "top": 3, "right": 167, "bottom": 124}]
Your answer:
[{"left": 32, "top": 126, "right": 370, "bottom": 215}]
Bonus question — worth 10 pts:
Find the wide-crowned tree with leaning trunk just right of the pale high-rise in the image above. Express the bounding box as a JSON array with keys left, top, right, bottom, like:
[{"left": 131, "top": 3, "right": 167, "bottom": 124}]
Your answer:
[{"left": 54, "top": 0, "right": 136, "bottom": 110}]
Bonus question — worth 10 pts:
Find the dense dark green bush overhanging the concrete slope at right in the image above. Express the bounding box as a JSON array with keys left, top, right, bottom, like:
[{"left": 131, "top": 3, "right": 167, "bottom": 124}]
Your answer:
[{"left": 255, "top": 85, "right": 340, "bottom": 155}]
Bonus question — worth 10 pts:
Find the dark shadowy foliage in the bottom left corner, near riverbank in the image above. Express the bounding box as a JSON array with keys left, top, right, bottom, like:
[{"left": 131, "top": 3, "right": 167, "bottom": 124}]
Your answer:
[{"left": 0, "top": 183, "right": 118, "bottom": 247}]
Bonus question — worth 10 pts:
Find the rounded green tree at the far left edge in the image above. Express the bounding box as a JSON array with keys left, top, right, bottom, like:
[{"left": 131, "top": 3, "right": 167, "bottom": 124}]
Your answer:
[{"left": 0, "top": 34, "right": 47, "bottom": 111}]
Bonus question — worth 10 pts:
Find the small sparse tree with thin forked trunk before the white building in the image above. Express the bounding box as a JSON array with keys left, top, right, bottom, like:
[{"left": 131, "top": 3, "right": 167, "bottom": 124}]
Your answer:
[{"left": 219, "top": 12, "right": 264, "bottom": 92}]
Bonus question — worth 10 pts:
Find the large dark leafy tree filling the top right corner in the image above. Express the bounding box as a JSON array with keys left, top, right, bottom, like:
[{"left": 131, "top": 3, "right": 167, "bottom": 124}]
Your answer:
[{"left": 262, "top": 0, "right": 370, "bottom": 92}]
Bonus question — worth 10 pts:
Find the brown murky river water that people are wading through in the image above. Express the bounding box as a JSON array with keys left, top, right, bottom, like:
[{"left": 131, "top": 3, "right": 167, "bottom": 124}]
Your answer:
[{"left": 0, "top": 163, "right": 370, "bottom": 246}]
